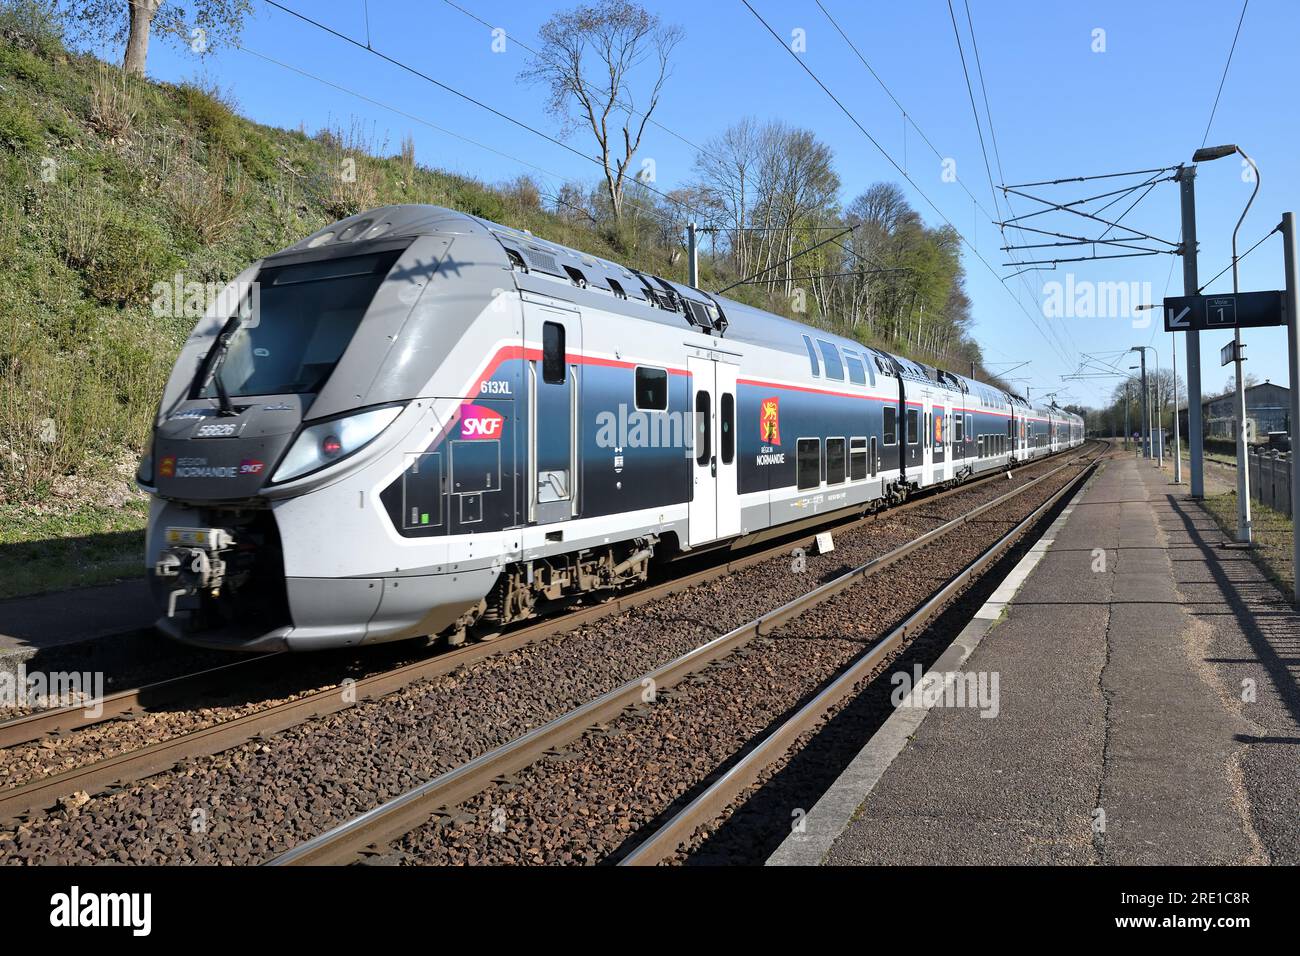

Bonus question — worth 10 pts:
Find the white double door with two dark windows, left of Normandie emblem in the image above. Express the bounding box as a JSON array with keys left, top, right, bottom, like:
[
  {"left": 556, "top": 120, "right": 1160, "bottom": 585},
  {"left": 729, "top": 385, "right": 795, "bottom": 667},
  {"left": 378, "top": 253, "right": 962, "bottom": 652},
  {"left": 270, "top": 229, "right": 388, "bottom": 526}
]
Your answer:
[{"left": 686, "top": 358, "right": 740, "bottom": 548}]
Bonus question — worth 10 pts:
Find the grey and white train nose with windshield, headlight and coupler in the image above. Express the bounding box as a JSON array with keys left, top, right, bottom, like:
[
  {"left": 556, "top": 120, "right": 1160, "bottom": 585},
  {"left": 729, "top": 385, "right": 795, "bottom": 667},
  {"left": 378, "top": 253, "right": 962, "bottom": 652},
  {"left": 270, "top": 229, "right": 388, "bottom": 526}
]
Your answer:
[{"left": 137, "top": 207, "right": 504, "bottom": 652}]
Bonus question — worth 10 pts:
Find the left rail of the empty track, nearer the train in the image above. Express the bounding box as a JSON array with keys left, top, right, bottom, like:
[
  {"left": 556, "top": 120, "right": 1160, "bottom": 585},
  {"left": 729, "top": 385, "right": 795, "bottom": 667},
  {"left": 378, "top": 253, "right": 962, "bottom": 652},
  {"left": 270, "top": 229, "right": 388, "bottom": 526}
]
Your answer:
[{"left": 268, "top": 442, "right": 1091, "bottom": 866}]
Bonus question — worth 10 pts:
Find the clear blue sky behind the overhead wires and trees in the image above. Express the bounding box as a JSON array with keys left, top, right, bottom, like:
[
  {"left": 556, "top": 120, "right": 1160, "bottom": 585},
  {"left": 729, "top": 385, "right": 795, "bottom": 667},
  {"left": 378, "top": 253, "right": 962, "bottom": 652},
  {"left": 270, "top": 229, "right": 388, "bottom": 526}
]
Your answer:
[{"left": 122, "top": 0, "right": 1300, "bottom": 405}]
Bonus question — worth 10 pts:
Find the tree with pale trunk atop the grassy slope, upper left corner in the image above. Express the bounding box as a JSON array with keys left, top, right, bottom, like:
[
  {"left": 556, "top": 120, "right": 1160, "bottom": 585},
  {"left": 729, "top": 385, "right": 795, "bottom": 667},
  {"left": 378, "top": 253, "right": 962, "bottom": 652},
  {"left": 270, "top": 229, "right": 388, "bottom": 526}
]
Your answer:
[{"left": 59, "top": 0, "right": 252, "bottom": 77}]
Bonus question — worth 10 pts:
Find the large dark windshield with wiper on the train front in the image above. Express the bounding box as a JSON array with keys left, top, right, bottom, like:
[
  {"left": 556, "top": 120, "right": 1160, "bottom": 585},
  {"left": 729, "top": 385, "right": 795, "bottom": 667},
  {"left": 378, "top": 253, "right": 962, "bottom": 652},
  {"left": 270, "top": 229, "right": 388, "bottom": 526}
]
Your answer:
[{"left": 199, "top": 250, "right": 402, "bottom": 398}]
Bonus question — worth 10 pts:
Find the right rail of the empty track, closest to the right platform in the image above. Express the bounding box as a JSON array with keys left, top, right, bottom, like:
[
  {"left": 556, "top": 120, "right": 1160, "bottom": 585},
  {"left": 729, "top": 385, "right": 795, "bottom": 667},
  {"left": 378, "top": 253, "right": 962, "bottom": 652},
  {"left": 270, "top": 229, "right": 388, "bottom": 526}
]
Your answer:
[{"left": 619, "top": 444, "right": 1100, "bottom": 866}]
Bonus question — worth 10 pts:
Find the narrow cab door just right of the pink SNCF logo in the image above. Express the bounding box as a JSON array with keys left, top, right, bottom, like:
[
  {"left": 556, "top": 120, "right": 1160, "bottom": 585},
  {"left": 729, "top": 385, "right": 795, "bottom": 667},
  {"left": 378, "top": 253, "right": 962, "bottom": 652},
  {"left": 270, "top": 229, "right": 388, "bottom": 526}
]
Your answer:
[{"left": 524, "top": 300, "right": 582, "bottom": 524}]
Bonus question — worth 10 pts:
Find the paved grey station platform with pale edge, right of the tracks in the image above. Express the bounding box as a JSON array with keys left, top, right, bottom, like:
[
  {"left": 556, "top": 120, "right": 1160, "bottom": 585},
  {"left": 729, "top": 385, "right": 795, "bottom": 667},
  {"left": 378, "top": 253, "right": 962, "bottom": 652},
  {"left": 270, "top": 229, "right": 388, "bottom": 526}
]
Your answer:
[{"left": 768, "top": 453, "right": 1300, "bottom": 865}]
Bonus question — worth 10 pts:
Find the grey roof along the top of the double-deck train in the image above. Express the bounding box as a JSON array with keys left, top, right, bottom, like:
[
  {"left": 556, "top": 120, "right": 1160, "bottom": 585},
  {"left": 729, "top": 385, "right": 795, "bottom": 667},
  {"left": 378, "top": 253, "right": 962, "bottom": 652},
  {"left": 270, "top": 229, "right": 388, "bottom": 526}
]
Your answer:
[{"left": 285, "top": 204, "right": 1078, "bottom": 418}]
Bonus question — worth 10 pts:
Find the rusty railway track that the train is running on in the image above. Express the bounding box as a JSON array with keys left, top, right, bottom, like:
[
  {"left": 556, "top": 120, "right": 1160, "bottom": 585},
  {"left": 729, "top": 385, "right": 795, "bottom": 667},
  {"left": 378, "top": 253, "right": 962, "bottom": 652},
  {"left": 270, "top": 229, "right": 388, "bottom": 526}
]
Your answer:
[{"left": 0, "top": 444, "right": 1086, "bottom": 821}]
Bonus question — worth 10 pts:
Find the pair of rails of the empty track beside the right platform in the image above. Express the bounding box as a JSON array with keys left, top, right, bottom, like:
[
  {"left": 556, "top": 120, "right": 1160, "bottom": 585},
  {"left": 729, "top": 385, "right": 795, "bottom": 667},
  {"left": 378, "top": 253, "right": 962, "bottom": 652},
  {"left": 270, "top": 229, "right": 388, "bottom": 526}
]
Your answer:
[{"left": 270, "top": 447, "right": 1101, "bottom": 865}]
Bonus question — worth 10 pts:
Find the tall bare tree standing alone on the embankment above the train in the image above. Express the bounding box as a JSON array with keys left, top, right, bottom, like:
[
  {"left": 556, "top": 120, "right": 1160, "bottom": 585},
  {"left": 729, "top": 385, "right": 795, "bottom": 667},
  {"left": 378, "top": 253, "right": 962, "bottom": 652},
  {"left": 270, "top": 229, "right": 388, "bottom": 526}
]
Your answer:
[{"left": 520, "top": 0, "right": 685, "bottom": 221}]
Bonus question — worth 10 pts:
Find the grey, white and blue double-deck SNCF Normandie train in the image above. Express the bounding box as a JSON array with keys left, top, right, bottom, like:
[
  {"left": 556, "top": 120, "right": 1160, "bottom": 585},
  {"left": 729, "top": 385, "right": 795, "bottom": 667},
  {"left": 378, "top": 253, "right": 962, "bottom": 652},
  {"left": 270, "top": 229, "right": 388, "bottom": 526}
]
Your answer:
[{"left": 137, "top": 204, "right": 1083, "bottom": 652}]
